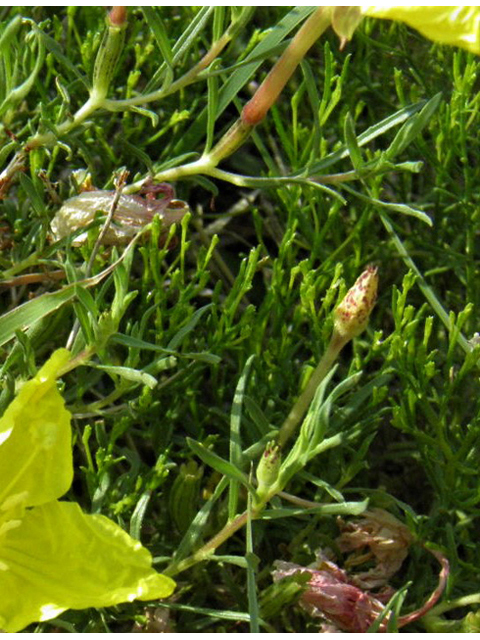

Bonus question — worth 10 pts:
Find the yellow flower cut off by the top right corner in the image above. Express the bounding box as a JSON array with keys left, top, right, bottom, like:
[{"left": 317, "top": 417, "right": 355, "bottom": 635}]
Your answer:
[{"left": 360, "top": 5, "right": 480, "bottom": 54}]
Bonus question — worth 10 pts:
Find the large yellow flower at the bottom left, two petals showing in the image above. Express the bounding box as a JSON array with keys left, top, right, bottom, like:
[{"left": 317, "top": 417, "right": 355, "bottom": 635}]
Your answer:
[{"left": 0, "top": 349, "right": 175, "bottom": 632}]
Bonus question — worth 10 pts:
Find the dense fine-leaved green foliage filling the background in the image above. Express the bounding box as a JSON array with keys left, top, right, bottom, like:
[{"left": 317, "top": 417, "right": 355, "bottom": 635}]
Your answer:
[{"left": 0, "top": 7, "right": 480, "bottom": 633}]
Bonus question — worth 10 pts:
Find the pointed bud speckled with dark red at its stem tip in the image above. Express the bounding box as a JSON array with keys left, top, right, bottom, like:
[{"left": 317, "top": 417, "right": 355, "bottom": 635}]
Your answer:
[{"left": 333, "top": 266, "right": 378, "bottom": 342}]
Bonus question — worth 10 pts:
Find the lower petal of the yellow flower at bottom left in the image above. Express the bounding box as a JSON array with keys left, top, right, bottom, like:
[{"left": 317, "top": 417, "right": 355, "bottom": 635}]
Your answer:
[{"left": 0, "top": 501, "right": 175, "bottom": 632}]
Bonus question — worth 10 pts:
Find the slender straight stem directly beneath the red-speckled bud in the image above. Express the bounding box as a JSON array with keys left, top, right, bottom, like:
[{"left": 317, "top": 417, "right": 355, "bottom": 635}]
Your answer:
[{"left": 277, "top": 332, "right": 348, "bottom": 447}]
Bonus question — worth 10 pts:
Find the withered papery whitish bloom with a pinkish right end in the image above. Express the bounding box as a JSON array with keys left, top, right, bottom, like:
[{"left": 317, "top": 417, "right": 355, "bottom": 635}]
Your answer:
[{"left": 51, "top": 191, "right": 189, "bottom": 246}]
